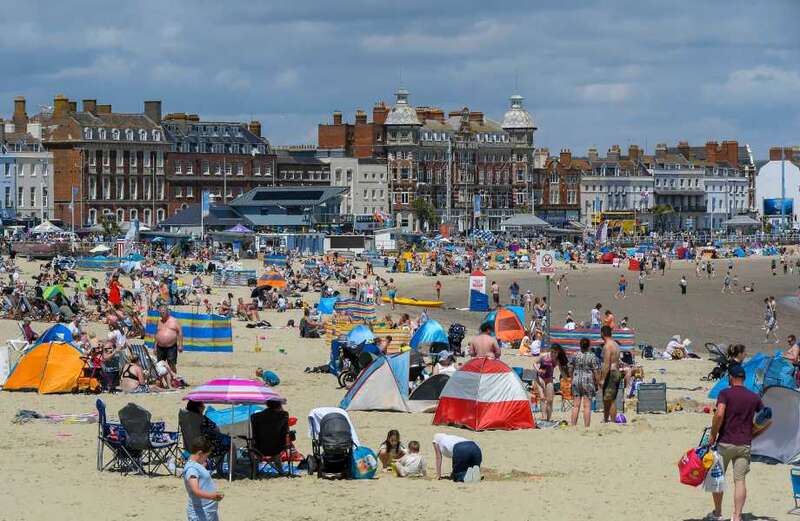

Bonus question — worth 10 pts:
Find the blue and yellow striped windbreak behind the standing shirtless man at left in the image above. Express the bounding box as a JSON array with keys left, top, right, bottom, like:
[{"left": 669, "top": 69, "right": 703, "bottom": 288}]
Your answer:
[{"left": 144, "top": 309, "right": 233, "bottom": 353}]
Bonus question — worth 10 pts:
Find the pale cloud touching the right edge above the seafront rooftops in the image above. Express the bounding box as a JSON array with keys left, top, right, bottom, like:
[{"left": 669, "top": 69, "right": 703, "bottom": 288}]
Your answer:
[{"left": 704, "top": 65, "right": 800, "bottom": 105}]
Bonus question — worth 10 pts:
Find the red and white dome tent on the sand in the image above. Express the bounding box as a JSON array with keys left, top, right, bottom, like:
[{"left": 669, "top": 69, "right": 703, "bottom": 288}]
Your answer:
[{"left": 433, "top": 358, "right": 535, "bottom": 431}]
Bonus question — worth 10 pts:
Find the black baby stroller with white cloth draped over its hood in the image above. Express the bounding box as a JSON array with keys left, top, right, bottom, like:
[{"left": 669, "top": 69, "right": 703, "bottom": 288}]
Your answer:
[{"left": 307, "top": 407, "right": 357, "bottom": 479}]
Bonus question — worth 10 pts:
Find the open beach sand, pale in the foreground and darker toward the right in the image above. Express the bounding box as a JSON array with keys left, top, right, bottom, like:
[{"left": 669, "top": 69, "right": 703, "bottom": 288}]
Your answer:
[{"left": 0, "top": 259, "right": 800, "bottom": 521}]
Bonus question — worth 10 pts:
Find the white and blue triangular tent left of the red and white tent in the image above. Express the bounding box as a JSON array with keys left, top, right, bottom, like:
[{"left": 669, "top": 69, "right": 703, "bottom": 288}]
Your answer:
[{"left": 339, "top": 351, "right": 411, "bottom": 412}]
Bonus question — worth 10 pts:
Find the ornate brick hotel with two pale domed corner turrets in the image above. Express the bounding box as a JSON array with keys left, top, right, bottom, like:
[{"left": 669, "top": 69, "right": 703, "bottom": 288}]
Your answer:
[{"left": 384, "top": 89, "right": 536, "bottom": 231}]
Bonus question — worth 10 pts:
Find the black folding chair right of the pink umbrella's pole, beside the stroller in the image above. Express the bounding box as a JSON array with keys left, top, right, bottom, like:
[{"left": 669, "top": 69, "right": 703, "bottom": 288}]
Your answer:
[{"left": 247, "top": 409, "right": 294, "bottom": 479}]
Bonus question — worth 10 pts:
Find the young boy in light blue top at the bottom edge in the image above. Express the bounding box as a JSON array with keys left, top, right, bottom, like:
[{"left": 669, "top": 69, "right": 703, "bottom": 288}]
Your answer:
[{"left": 183, "top": 436, "right": 223, "bottom": 521}]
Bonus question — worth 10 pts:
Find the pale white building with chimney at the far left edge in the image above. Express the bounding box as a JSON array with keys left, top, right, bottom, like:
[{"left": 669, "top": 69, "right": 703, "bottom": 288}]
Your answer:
[{"left": 0, "top": 97, "right": 53, "bottom": 222}]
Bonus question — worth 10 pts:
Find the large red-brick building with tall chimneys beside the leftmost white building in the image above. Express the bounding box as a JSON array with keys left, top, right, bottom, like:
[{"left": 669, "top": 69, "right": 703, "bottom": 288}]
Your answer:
[{"left": 34, "top": 95, "right": 169, "bottom": 227}]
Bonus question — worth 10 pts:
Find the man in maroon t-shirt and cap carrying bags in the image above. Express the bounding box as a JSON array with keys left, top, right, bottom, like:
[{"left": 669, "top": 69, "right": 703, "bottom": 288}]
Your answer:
[{"left": 707, "top": 364, "right": 769, "bottom": 521}]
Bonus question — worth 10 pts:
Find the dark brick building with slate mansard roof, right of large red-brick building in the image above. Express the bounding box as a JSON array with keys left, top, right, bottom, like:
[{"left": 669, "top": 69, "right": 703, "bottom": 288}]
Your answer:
[{"left": 161, "top": 113, "right": 276, "bottom": 215}]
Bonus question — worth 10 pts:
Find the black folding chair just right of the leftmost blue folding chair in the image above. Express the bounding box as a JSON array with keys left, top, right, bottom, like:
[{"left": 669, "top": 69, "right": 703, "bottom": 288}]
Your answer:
[{"left": 119, "top": 403, "right": 178, "bottom": 477}]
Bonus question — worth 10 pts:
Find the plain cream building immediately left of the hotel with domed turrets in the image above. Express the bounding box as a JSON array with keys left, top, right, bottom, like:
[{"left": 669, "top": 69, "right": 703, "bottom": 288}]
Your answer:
[{"left": 320, "top": 157, "right": 390, "bottom": 231}]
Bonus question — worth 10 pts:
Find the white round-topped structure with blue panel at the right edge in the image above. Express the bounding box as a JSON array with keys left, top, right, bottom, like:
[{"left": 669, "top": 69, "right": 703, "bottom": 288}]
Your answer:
[{"left": 756, "top": 148, "right": 800, "bottom": 228}]
